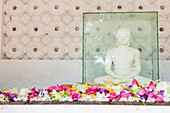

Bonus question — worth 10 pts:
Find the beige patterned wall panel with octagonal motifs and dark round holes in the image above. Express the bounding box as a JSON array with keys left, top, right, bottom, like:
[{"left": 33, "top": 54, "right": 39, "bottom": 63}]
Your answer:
[{"left": 3, "top": 0, "right": 170, "bottom": 60}]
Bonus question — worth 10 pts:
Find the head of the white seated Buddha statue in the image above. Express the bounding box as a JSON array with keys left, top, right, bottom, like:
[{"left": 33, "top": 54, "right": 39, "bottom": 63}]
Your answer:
[{"left": 116, "top": 28, "right": 131, "bottom": 46}]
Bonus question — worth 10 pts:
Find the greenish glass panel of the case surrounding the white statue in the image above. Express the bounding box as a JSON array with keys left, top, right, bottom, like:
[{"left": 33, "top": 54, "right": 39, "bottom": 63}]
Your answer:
[{"left": 82, "top": 12, "right": 159, "bottom": 82}]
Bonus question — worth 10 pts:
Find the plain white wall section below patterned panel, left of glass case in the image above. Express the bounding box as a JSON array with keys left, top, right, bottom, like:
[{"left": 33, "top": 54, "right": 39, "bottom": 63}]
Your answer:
[{"left": 0, "top": 60, "right": 82, "bottom": 89}]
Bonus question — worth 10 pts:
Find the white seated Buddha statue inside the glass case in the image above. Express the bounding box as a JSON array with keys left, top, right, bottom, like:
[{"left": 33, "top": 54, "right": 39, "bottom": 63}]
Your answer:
[{"left": 94, "top": 28, "right": 152, "bottom": 85}]
